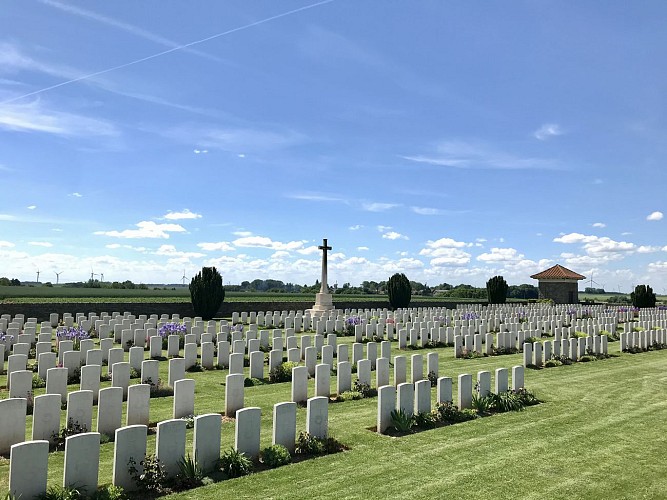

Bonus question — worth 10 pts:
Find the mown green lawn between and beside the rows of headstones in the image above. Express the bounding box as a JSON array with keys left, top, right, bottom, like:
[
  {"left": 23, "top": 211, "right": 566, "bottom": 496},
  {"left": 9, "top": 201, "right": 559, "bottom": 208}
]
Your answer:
[{"left": 0, "top": 324, "right": 667, "bottom": 499}]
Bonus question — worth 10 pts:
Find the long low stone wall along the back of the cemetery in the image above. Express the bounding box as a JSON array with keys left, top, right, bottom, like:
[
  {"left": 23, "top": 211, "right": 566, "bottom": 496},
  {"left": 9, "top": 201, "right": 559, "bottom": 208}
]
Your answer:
[{"left": 0, "top": 299, "right": 486, "bottom": 321}]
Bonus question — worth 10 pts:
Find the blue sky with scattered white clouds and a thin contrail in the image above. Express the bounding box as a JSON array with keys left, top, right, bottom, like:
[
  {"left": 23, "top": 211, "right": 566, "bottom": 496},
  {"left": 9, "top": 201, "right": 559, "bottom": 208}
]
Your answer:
[{"left": 0, "top": 0, "right": 667, "bottom": 293}]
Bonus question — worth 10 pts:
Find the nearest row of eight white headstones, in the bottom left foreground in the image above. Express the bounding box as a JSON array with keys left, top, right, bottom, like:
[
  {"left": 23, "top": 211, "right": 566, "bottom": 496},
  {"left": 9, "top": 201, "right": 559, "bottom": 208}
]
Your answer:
[{"left": 5, "top": 397, "right": 329, "bottom": 498}]
